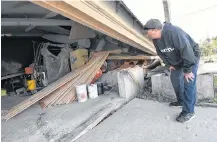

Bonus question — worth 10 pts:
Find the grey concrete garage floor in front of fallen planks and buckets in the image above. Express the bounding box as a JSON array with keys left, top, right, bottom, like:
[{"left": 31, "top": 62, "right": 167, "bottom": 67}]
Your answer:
[{"left": 1, "top": 92, "right": 126, "bottom": 142}]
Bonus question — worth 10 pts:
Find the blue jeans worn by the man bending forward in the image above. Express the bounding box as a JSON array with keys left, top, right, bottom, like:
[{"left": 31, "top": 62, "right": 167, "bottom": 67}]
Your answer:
[{"left": 170, "top": 60, "right": 199, "bottom": 113}]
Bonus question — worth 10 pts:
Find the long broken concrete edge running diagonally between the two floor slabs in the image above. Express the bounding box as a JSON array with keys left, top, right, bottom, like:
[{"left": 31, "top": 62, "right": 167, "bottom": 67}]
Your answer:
[{"left": 55, "top": 97, "right": 135, "bottom": 142}]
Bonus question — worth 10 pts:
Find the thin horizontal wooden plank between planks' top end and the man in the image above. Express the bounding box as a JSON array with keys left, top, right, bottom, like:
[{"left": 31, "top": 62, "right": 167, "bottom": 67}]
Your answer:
[{"left": 107, "top": 55, "right": 159, "bottom": 60}]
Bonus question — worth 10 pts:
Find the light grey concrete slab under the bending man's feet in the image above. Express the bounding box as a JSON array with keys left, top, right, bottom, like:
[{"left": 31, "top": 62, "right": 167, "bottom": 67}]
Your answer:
[{"left": 77, "top": 99, "right": 217, "bottom": 142}]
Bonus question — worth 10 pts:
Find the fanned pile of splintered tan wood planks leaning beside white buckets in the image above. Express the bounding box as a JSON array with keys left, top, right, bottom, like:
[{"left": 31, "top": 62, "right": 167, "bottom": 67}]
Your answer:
[{"left": 2, "top": 52, "right": 109, "bottom": 121}]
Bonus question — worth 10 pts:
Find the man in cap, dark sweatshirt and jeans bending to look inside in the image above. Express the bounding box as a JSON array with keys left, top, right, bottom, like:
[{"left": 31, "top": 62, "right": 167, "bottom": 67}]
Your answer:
[{"left": 144, "top": 19, "right": 200, "bottom": 123}]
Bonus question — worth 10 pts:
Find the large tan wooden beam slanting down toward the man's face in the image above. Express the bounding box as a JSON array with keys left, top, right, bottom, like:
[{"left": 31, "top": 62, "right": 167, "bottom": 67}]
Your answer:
[{"left": 31, "top": 1, "right": 156, "bottom": 55}]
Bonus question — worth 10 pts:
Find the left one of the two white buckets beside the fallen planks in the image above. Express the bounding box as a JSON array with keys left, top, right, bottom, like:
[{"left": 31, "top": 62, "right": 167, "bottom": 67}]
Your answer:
[{"left": 76, "top": 84, "right": 87, "bottom": 102}]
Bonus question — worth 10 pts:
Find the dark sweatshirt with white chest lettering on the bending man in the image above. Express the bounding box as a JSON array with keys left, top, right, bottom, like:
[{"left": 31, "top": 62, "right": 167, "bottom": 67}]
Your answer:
[{"left": 153, "top": 23, "right": 200, "bottom": 73}]
